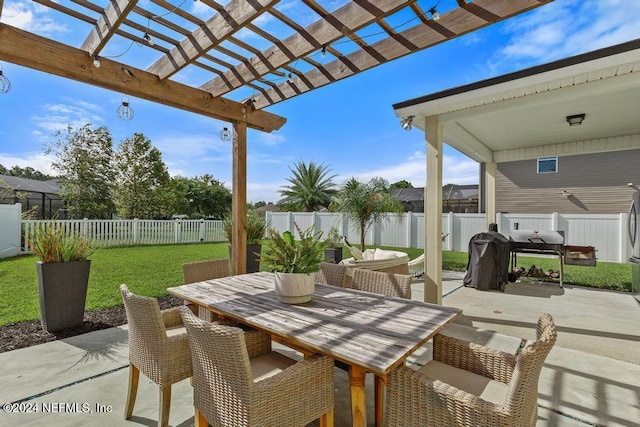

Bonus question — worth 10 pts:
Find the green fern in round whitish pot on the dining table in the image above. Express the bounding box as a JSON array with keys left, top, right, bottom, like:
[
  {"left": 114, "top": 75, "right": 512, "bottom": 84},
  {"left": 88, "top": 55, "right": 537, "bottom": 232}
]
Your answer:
[{"left": 260, "top": 224, "right": 325, "bottom": 304}]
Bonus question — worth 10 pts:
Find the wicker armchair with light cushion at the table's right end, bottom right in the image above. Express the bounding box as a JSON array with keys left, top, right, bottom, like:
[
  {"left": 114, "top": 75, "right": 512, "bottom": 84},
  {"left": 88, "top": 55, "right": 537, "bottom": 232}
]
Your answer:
[{"left": 385, "top": 313, "right": 557, "bottom": 427}]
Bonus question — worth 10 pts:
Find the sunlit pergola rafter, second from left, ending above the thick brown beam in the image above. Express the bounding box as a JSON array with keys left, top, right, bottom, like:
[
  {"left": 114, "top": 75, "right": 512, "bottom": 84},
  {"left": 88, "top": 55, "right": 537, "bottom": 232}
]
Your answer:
[{"left": 147, "top": 0, "right": 280, "bottom": 79}]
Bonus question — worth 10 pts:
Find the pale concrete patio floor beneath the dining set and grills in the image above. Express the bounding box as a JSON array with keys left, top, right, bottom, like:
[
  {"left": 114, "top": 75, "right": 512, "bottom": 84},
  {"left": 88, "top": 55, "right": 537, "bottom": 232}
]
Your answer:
[{"left": 0, "top": 272, "right": 640, "bottom": 427}]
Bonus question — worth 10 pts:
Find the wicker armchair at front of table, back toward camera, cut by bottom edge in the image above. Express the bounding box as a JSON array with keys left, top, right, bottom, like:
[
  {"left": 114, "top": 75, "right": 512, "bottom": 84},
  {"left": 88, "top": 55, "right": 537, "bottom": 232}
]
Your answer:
[{"left": 181, "top": 307, "right": 334, "bottom": 427}]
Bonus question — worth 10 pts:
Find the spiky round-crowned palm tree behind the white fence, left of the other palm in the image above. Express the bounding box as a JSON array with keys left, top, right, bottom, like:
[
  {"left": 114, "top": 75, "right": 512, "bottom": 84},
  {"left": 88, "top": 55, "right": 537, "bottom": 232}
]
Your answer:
[{"left": 280, "top": 161, "right": 336, "bottom": 212}]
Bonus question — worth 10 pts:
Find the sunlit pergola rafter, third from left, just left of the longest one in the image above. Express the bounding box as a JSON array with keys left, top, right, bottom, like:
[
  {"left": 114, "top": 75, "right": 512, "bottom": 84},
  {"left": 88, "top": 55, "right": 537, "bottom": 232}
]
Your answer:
[{"left": 201, "top": 0, "right": 416, "bottom": 99}]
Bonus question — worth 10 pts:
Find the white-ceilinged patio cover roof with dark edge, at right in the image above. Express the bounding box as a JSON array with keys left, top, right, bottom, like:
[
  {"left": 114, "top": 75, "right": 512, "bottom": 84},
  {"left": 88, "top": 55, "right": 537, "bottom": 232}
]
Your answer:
[{"left": 393, "top": 39, "right": 640, "bottom": 162}]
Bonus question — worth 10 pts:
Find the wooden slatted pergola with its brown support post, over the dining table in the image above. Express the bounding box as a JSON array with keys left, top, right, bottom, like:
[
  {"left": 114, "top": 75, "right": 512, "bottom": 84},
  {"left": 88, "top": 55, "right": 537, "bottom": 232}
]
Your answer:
[{"left": 0, "top": 0, "right": 553, "bottom": 273}]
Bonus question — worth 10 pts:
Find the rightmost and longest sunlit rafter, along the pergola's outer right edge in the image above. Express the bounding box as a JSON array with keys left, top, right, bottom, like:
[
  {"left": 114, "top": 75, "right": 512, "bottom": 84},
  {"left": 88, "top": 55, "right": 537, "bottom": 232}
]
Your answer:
[{"left": 252, "top": 0, "right": 553, "bottom": 109}]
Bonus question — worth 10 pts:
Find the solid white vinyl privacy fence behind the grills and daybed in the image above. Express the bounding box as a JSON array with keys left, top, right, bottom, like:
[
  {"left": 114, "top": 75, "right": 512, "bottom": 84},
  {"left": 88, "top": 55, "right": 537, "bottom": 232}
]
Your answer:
[{"left": 267, "top": 212, "right": 631, "bottom": 262}]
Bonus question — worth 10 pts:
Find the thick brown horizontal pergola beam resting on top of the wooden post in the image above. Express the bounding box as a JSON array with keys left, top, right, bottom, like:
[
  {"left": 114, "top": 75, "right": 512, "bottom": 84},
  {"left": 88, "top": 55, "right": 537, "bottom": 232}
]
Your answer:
[{"left": 0, "top": 23, "right": 286, "bottom": 132}]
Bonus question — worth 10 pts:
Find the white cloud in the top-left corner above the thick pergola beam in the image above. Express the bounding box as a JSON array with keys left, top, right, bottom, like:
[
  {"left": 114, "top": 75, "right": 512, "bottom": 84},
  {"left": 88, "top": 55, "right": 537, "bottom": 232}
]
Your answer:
[{"left": 2, "top": 1, "right": 69, "bottom": 35}]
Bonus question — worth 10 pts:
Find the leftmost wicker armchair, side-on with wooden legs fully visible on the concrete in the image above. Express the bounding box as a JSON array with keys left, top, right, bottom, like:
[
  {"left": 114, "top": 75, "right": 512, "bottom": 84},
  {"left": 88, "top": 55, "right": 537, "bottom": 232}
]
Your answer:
[{"left": 120, "top": 285, "right": 192, "bottom": 427}]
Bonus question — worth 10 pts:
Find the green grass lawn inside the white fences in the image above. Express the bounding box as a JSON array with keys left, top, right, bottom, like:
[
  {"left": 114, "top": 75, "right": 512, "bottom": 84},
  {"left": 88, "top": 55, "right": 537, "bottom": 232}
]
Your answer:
[{"left": 0, "top": 243, "right": 631, "bottom": 326}]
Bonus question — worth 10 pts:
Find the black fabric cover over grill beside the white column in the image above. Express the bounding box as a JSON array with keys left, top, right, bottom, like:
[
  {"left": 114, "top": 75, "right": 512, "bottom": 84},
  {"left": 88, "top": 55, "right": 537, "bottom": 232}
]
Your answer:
[{"left": 463, "top": 231, "right": 510, "bottom": 290}]
